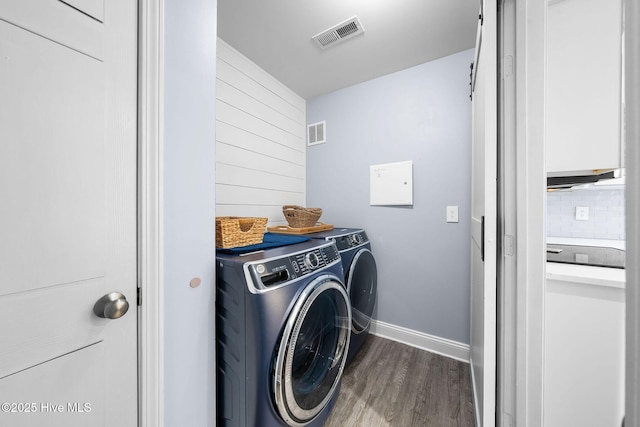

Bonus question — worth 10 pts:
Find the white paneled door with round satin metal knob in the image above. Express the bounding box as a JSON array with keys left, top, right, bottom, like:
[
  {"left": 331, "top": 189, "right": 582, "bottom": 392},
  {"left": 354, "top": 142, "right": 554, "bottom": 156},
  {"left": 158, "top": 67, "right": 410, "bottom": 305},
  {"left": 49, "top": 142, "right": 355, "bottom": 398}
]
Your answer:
[{"left": 0, "top": 0, "right": 137, "bottom": 427}]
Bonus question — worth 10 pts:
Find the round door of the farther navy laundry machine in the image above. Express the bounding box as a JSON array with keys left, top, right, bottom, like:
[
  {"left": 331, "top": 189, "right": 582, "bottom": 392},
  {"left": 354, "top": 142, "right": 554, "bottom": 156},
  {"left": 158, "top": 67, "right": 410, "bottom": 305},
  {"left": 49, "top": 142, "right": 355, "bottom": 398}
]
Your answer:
[{"left": 347, "top": 249, "right": 378, "bottom": 334}]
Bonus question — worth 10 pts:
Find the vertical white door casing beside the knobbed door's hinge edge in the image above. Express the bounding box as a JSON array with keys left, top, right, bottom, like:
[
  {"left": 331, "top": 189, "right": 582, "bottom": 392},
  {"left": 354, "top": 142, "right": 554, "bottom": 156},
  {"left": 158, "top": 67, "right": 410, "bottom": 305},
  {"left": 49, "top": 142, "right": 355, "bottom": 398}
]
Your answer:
[{"left": 138, "top": 0, "right": 164, "bottom": 427}]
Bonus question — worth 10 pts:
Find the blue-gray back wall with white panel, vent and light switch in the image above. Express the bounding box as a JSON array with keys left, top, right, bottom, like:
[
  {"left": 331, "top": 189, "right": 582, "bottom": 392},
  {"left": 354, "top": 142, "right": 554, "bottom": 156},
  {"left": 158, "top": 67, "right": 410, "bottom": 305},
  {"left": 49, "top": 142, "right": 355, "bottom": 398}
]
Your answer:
[{"left": 307, "top": 50, "right": 473, "bottom": 344}]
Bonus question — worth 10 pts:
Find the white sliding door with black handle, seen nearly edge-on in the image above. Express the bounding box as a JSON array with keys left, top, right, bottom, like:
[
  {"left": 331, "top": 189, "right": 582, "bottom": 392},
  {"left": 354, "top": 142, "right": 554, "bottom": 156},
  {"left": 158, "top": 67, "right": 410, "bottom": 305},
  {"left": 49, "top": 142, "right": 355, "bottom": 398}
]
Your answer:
[{"left": 470, "top": 0, "right": 498, "bottom": 427}]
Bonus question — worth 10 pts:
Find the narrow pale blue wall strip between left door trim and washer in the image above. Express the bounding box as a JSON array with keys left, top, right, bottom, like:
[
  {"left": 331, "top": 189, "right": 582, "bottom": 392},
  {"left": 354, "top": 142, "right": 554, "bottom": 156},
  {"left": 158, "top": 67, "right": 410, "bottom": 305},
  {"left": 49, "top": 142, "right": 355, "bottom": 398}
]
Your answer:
[{"left": 163, "top": 0, "right": 217, "bottom": 427}]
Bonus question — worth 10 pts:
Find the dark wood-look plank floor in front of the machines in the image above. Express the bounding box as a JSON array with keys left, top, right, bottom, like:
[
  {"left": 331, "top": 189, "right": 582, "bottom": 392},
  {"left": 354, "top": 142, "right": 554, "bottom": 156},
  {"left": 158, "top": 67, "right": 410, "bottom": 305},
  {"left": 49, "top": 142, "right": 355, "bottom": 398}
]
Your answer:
[{"left": 324, "top": 335, "right": 474, "bottom": 427}]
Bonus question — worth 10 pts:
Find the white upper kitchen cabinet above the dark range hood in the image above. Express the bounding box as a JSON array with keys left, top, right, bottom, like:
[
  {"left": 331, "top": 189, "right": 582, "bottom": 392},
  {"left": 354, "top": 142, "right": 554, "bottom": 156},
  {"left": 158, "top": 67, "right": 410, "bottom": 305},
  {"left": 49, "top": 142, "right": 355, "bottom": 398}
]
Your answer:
[{"left": 546, "top": 0, "right": 623, "bottom": 176}]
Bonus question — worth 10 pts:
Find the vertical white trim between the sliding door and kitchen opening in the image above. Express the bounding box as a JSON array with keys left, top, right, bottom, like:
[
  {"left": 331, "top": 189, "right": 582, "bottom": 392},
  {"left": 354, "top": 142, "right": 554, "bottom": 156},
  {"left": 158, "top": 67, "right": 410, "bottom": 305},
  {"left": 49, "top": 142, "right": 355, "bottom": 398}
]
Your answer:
[{"left": 514, "top": 0, "right": 547, "bottom": 427}]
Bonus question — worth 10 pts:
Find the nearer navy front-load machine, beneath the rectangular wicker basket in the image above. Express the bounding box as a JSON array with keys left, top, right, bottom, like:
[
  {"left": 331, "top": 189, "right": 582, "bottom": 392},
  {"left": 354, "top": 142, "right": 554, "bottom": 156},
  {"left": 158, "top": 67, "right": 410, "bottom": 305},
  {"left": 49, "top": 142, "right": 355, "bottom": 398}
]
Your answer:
[{"left": 216, "top": 240, "right": 351, "bottom": 427}]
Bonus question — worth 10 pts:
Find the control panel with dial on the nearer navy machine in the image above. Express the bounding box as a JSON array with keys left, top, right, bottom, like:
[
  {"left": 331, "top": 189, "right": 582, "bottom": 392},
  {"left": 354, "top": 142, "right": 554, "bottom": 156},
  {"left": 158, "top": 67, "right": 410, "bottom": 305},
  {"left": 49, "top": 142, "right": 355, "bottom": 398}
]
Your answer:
[{"left": 245, "top": 244, "right": 340, "bottom": 290}]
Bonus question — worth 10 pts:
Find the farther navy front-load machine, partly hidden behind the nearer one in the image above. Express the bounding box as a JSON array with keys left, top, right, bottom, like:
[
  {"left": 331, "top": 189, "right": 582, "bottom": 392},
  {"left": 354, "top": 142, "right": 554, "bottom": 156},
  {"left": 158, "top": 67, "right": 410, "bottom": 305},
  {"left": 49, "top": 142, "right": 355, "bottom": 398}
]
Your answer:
[{"left": 282, "top": 227, "right": 378, "bottom": 363}]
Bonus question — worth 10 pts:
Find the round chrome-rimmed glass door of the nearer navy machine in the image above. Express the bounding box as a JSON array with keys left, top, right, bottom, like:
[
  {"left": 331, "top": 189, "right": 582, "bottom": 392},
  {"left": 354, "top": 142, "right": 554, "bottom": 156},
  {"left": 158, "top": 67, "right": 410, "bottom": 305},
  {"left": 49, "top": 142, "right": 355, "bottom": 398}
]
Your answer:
[{"left": 273, "top": 275, "right": 351, "bottom": 426}]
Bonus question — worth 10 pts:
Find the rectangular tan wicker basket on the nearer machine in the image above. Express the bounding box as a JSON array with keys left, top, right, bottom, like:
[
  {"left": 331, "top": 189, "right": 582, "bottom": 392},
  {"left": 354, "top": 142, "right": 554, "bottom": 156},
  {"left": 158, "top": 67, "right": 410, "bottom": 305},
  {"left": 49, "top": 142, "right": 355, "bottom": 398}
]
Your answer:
[{"left": 216, "top": 216, "right": 268, "bottom": 249}]
